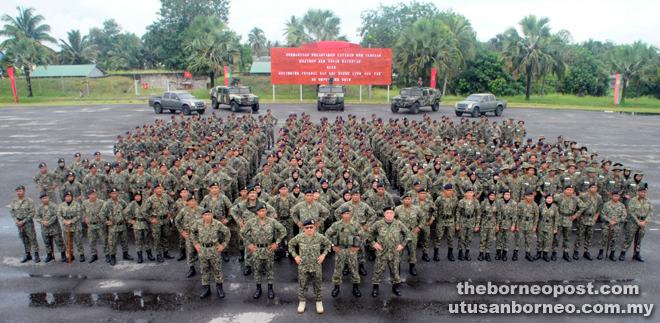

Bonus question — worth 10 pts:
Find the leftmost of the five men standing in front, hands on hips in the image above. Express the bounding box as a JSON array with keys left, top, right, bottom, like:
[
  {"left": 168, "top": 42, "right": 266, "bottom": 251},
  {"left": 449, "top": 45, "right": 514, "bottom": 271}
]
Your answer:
[{"left": 190, "top": 209, "right": 231, "bottom": 298}]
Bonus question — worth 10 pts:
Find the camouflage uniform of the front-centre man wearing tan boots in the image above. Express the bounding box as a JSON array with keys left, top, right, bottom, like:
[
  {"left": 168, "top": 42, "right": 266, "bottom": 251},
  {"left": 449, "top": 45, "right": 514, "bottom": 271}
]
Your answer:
[{"left": 289, "top": 232, "right": 332, "bottom": 302}]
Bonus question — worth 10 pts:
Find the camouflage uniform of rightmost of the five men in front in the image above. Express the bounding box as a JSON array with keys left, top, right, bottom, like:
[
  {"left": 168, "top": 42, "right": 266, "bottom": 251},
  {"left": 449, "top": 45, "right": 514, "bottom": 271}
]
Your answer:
[{"left": 369, "top": 219, "right": 411, "bottom": 285}]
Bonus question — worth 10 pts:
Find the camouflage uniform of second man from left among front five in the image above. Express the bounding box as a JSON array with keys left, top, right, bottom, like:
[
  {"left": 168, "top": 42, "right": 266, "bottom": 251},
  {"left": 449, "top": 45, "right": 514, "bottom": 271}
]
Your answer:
[{"left": 241, "top": 217, "right": 286, "bottom": 285}]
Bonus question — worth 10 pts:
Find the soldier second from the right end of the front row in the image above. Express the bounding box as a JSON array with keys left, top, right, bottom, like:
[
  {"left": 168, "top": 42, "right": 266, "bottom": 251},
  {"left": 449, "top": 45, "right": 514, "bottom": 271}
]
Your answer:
[{"left": 598, "top": 191, "right": 628, "bottom": 261}]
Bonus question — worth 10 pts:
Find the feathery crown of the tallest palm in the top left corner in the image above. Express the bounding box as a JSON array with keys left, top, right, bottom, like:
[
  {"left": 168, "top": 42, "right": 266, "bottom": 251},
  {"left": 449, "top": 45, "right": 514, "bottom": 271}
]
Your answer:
[{"left": 0, "top": 6, "right": 57, "bottom": 50}]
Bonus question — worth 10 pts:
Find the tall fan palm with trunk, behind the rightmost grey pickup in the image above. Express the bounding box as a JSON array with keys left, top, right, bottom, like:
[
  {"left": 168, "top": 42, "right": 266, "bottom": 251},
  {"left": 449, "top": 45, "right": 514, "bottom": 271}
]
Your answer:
[{"left": 498, "top": 15, "right": 563, "bottom": 100}]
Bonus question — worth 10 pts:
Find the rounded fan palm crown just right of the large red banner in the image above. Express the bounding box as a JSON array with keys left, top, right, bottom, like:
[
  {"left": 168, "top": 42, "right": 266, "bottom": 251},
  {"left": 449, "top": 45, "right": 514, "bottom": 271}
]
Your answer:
[{"left": 394, "top": 18, "right": 458, "bottom": 85}]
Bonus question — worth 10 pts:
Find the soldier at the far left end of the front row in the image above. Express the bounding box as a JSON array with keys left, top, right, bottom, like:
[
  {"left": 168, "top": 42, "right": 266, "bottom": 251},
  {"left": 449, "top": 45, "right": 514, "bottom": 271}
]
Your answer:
[{"left": 9, "top": 185, "right": 40, "bottom": 263}]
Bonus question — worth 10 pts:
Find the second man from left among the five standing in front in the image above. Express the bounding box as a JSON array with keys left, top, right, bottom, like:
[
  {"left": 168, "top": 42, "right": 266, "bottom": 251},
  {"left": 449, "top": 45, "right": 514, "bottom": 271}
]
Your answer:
[{"left": 241, "top": 203, "right": 286, "bottom": 299}]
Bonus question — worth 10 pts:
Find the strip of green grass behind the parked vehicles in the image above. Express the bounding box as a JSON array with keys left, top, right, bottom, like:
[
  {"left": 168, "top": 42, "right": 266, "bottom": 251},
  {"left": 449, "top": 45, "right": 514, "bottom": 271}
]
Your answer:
[{"left": 0, "top": 74, "right": 660, "bottom": 113}]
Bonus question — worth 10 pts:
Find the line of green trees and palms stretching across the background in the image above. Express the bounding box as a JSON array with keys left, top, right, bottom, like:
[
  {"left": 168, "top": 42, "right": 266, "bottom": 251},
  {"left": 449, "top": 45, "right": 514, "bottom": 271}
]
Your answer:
[{"left": 0, "top": 0, "right": 660, "bottom": 102}]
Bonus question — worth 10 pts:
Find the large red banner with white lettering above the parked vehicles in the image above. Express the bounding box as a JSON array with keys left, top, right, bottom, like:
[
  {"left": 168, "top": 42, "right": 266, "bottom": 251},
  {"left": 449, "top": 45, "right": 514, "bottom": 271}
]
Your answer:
[{"left": 270, "top": 47, "right": 392, "bottom": 85}]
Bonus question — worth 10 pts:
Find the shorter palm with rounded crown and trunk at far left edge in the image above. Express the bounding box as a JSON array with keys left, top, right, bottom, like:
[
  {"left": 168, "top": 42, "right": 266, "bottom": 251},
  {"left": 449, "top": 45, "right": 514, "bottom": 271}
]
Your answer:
[{"left": 3, "top": 37, "right": 50, "bottom": 97}]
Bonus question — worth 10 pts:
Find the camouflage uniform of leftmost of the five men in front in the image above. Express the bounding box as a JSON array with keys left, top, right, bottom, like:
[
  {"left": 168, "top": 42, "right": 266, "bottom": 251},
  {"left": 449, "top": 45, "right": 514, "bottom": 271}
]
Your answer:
[{"left": 190, "top": 219, "right": 231, "bottom": 286}]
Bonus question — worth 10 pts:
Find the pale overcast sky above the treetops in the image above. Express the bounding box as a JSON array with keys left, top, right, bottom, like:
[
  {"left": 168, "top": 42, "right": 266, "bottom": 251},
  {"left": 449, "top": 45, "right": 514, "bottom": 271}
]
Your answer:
[{"left": 0, "top": 0, "right": 660, "bottom": 47}]
